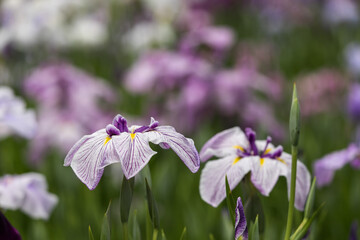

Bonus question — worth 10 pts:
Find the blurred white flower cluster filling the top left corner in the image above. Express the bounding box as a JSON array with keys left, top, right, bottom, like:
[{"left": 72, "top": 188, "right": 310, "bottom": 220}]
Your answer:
[{"left": 0, "top": 0, "right": 107, "bottom": 49}]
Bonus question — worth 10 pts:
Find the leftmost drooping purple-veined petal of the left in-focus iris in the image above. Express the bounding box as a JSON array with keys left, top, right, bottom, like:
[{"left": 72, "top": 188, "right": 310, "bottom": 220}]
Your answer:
[{"left": 64, "top": 129, "right": 120, "bottom": 190}]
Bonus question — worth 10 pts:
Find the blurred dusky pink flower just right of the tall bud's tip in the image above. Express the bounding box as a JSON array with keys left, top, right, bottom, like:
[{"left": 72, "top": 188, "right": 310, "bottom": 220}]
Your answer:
[{"left": 295, "top": 69, "right": 347, "bottom": 117}]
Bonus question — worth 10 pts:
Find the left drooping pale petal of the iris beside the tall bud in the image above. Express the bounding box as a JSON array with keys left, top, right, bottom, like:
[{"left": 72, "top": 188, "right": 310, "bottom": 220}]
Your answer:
[{"left": 200, "top": 155, "right": 253, "bottom": 207}]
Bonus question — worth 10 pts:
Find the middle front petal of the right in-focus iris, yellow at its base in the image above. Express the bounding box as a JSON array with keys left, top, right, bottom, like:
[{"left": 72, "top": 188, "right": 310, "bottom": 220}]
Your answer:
[{"left": 251, "top": 157, "right": 287, "bottom": 196}]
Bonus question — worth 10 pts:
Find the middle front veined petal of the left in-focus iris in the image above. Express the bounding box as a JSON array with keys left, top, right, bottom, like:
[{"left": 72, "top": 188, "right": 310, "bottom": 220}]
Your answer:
[{"left": 113, "top": 133, "right": 156, "bottom": 179}]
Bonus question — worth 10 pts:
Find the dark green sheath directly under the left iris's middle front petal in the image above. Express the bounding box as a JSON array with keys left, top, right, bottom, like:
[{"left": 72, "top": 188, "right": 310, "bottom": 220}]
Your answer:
[{"left": 120, "top": 176, "right": 135, "bottom": 223}]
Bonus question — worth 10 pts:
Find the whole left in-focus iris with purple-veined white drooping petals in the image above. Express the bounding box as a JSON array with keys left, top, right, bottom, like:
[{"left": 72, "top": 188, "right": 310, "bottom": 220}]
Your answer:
[{"left": 64, "top": 114, "right": 200, "bottom": 190}]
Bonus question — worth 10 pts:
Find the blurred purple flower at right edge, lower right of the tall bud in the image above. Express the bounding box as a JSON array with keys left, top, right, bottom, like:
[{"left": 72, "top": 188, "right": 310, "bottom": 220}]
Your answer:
[{"left": 314, "top": 144, "right": 360, "bottom": 187}]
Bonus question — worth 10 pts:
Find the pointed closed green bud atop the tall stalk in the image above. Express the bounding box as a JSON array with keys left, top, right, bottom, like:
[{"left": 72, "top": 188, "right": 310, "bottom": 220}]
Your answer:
[{"left": 289, "top": 83, "right": 300, "bottom": 146}]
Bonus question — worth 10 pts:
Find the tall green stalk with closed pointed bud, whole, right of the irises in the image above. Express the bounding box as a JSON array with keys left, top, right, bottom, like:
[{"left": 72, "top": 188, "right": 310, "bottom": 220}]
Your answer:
[{"left": 285, "top": 84, "right": 300, "bottom": 240}]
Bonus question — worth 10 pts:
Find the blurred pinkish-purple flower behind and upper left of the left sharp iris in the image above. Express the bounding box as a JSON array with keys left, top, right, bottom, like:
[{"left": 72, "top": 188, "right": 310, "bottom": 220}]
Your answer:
[{"left": 25, "top": 63, "right": 115, "bottom": 162}]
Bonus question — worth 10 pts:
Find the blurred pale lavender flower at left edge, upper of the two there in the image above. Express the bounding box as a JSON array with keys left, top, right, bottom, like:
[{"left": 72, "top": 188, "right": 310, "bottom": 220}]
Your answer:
[{"left": 0, "top": 86, "right": 37, "bottom": 138}]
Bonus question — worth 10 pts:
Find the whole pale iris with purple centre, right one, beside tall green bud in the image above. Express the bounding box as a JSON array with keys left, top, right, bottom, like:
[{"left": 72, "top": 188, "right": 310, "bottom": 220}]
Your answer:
[{"left": 200, "top": 127, "right": 310, "bottom": 210}]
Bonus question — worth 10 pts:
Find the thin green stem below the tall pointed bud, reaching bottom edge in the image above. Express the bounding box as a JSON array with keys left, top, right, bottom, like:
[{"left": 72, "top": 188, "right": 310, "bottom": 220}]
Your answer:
[{"left": 285, "top": 146, "right": 298, "bottom": 240}]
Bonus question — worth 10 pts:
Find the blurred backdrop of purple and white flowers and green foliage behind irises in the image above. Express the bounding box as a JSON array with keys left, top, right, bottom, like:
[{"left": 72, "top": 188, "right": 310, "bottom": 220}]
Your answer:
[{"left": 0, "top": 0, "right": 360, "bottom": 240}]
